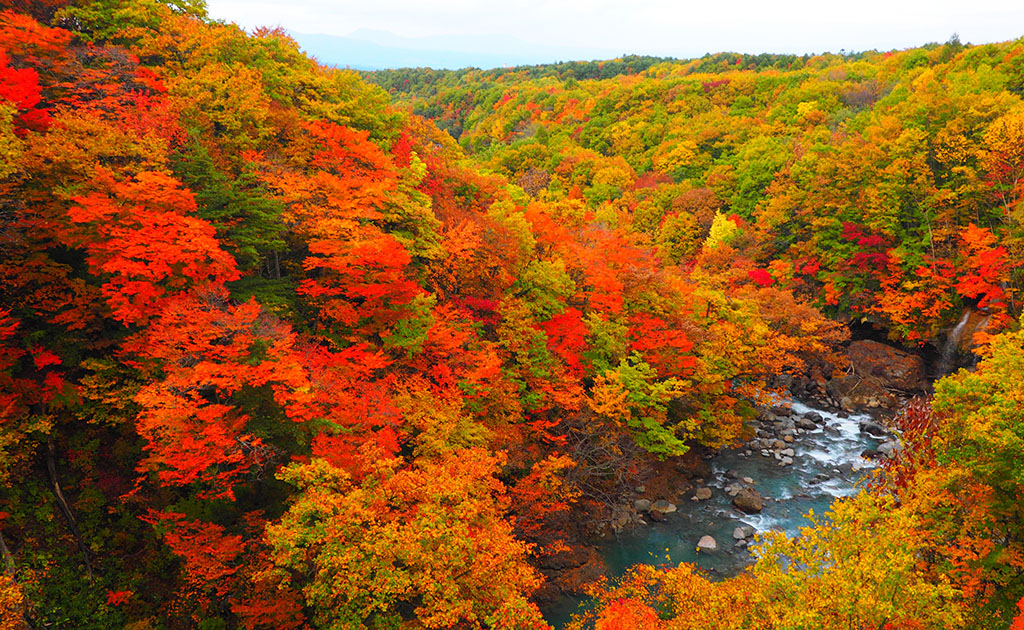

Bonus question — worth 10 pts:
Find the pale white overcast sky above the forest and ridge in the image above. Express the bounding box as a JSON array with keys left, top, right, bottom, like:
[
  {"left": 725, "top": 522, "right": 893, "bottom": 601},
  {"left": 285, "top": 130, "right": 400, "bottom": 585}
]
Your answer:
[{"left": 208, "top": 0, "right": 1024, "bottom": 58}]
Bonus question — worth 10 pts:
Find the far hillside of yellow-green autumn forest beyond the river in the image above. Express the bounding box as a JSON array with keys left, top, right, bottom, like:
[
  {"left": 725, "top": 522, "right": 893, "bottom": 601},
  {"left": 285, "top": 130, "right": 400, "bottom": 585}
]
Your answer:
[{"left": 370, "top": 40, "right": 1024, "bottom": 343}]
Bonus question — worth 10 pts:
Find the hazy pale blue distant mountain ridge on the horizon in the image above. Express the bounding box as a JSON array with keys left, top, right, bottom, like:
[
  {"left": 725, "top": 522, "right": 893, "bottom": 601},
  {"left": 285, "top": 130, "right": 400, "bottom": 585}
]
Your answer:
[{"left": 291, "top": 29, "right": 622, "bottom": 71}]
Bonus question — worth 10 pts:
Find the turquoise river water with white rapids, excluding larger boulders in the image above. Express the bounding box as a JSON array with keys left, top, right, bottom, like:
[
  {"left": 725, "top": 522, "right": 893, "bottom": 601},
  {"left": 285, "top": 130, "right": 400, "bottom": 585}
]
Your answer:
[{"left": 546, "top": 402, "right": 886, "bottom": 628}]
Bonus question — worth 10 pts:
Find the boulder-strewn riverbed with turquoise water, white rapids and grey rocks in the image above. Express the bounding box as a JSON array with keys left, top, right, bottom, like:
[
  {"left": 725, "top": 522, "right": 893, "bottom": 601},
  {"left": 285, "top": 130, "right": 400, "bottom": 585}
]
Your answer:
[{"left": 549, "top": 402, "right": 899, "bottom": 627}]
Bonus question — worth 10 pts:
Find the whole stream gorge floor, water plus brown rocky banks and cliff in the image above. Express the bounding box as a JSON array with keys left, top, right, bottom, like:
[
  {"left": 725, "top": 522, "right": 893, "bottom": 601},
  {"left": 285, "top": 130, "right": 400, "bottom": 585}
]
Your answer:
[{"left": 544, "top": 327, "right": 987, "bottom": 628}]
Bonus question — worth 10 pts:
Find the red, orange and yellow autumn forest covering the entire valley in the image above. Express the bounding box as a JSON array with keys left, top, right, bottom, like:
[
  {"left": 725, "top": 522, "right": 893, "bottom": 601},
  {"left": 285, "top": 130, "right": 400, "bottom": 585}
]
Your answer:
[{"left": 0, "top": 0, "right": 1024, "bottom": 630}]
